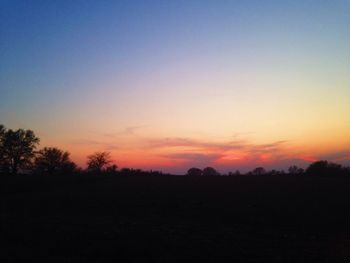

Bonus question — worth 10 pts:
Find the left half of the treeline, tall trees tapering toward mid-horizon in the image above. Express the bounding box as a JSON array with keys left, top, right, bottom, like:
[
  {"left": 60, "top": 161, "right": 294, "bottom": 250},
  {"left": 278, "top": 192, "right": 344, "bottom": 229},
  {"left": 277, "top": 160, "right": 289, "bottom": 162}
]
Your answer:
[{"left": 0, "top": 125, "right": 167, "bottom": 176}]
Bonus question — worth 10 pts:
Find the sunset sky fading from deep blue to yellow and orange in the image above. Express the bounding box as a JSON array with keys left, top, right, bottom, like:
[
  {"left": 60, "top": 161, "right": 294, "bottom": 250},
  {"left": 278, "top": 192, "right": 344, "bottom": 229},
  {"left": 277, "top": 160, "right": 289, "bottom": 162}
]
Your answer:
[{"left": 0, "top": 0, "right": 350, "bottom": 174}]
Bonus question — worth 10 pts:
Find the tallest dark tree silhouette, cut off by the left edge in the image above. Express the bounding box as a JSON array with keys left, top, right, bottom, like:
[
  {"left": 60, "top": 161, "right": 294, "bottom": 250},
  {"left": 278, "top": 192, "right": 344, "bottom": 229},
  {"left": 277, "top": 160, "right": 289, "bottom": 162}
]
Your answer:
[{"left": 0, "top": 126, "right": 39, "bottom": 174}]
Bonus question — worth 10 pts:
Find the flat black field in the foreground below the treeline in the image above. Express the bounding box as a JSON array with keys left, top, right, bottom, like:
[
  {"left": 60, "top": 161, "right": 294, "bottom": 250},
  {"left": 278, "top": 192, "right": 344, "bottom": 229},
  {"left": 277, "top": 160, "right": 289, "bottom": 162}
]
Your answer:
[{"left": 0, "top": 176, "right": 350, "bottom": 263}]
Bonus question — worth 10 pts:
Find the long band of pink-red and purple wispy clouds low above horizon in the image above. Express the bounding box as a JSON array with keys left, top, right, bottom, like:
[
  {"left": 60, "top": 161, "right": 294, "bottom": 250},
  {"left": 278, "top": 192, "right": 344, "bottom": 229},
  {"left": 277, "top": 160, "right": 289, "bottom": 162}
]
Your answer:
[{"left": 74, "top": 134, "right": 350, "bottom": 172}]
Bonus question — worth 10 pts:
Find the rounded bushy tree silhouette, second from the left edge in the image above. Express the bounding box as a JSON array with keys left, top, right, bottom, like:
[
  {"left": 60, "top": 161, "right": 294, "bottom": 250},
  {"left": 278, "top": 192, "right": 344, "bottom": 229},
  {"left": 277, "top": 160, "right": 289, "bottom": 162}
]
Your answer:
[{"left": 34, "top": 147, "right": 76, "bottom": 174}]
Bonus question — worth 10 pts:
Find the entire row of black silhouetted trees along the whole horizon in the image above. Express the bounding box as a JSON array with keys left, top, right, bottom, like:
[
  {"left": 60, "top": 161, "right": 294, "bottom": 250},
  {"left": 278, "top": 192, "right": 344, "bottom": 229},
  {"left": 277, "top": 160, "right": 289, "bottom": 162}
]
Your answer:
[{"left": 0, "top": 125, "right": 350, "bottom": 177}]
